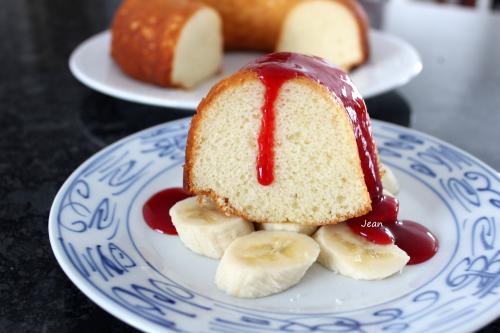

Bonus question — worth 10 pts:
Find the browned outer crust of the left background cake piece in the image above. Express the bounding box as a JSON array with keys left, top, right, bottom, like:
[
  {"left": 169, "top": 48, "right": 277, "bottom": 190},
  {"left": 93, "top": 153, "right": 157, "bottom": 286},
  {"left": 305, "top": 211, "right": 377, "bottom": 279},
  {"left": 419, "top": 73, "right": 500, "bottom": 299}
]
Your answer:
[{"left": 111, "top": 0, "right": 204, "bottom": 87}]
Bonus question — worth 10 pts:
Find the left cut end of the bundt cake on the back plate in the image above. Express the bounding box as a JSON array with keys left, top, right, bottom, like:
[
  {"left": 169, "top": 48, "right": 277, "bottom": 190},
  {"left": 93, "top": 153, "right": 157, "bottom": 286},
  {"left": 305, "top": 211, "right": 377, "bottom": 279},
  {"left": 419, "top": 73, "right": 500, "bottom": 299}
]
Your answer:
[{"left": 111, "top": 0, "right": 223, "bottom": 88}]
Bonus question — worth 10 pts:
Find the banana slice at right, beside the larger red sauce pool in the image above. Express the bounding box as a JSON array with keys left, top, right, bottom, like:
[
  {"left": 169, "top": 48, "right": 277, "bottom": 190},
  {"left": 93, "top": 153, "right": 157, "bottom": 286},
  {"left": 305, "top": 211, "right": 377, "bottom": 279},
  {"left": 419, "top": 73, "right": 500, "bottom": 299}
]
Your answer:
[{"left": 313, "top": 223, "right": 410, "bottom": 280}]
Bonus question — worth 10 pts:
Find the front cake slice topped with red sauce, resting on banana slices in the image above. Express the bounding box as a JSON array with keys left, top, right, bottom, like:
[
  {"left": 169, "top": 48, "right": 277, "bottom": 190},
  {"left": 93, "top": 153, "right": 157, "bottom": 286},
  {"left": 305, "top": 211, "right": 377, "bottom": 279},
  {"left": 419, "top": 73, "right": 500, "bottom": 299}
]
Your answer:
[{"left": 184, "top": 53, "right": 382, "bottom": 225}]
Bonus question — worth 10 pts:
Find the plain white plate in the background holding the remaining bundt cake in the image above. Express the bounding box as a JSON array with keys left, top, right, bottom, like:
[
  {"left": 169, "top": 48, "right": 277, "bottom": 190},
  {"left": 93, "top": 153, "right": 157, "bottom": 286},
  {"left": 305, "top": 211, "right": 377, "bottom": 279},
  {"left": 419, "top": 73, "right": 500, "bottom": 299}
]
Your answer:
[{"left": 69, "top": 31, "right": 422, "bottom": 110}]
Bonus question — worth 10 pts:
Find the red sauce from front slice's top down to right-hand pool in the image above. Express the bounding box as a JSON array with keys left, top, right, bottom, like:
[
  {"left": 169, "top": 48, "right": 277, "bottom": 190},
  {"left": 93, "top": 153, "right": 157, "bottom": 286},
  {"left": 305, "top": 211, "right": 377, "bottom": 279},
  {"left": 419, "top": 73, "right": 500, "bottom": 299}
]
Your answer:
[{"left": 246, "top": 52, "right": 438, "bottom": 264}]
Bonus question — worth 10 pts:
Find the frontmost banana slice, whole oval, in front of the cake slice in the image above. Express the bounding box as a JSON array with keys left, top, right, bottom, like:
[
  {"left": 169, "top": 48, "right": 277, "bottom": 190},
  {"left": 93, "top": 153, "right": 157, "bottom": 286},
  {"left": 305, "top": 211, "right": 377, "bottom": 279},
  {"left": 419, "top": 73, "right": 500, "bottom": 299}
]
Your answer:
[{"left": 215, "top": 230, "right": 319, "bottom": 298}]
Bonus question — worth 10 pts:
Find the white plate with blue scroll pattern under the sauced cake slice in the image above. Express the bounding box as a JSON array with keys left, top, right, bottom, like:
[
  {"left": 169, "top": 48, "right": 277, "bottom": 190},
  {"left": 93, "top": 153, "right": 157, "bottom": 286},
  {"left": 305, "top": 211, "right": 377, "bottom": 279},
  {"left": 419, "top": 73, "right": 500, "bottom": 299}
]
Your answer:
[{"left": 49, "top": 119, "right": 500, "bottom": 333}]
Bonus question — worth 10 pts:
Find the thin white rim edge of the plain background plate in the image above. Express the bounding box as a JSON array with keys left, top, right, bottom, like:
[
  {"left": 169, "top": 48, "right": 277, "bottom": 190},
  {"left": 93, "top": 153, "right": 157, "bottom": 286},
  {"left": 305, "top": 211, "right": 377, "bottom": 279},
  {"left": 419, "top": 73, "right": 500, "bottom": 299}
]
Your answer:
[{"left": 68, "top": 28, "right": 423, "bottom": 112}]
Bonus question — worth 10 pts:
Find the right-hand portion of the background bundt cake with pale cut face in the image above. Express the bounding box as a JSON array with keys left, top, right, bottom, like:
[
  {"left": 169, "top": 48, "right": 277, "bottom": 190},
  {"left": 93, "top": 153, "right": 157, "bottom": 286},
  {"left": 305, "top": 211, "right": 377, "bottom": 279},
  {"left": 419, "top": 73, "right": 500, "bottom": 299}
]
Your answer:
[{"left": 200, "top": 0, "right": 369, "bottom": 70}]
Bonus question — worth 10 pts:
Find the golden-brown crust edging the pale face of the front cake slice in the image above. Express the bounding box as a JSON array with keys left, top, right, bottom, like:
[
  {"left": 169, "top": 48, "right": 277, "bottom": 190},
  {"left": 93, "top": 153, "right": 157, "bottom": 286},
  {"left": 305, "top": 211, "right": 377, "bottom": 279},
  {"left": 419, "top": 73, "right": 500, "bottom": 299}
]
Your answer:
[{"left": 184, "top": 69, "right": 372, "bottom": 225}]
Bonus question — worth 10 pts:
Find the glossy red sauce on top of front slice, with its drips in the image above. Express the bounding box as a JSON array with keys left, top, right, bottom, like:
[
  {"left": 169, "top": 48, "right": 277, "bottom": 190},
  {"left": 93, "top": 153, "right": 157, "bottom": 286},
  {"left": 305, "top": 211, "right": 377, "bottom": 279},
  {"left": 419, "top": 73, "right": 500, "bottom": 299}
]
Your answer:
[{"left": 246, "top": 52, "right": 382, "bottom": 192}]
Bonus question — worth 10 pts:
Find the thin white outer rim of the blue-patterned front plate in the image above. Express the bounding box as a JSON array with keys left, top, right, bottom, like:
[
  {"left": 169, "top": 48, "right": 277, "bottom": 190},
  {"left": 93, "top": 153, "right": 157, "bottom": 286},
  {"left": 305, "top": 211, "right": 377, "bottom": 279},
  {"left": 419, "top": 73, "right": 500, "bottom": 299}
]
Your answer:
[{"left": 47, "top": 117, "right": 500, "bottom": 332}]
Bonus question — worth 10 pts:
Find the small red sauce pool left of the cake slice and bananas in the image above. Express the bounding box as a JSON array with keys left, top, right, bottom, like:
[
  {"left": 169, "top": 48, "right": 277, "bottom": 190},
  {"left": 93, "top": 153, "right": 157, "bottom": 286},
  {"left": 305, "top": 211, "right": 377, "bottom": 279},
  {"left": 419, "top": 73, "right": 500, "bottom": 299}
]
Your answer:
[{"left": 142, "top": 187, "right": 191, "bottom": 235}]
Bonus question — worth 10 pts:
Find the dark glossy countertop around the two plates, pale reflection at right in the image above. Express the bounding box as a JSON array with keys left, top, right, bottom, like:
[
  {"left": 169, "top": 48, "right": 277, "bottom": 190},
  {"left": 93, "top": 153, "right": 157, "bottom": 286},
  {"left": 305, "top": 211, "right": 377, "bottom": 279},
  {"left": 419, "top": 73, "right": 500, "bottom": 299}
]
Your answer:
[{"left": 0, "top": 0, "right": 500, "bottom": 333}]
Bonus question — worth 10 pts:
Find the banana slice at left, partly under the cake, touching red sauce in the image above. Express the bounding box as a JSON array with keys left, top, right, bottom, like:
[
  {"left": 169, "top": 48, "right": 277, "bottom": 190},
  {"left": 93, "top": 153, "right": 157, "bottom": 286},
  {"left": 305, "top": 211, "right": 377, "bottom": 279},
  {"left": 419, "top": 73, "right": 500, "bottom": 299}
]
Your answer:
[{"left": 170, "top": 197, "right": 254, "bottom": 258}]
